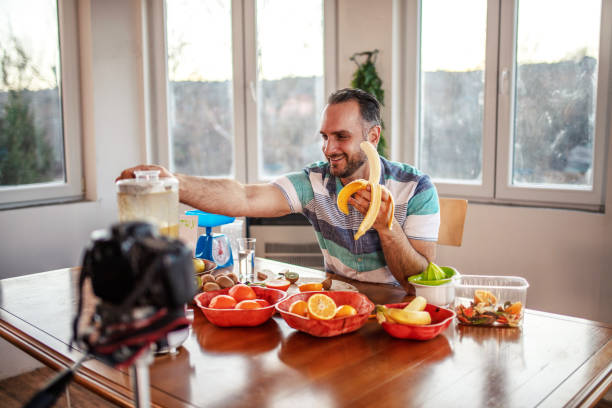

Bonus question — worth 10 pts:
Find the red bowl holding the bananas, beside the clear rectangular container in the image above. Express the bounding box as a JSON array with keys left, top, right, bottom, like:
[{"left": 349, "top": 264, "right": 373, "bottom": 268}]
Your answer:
[{"left": 382, "top": 302, "right": 456, "bottom": 340}]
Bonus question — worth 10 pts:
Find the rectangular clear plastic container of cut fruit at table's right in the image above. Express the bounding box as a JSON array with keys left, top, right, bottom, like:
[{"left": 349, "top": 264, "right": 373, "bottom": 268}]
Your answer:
[{"left": 454, "top": 275, "right": 529, "bottom": 327}]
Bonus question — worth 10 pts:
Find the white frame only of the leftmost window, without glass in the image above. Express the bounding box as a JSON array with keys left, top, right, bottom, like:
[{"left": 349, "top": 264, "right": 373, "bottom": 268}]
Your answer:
[{"left": 0, "top": 0, "right": 84, "bottom": 209}]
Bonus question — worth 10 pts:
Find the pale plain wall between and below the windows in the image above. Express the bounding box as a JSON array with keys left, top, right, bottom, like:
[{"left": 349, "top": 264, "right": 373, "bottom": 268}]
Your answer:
[{"left": 0, "top": 0, "right": 612, "bottom": 322}]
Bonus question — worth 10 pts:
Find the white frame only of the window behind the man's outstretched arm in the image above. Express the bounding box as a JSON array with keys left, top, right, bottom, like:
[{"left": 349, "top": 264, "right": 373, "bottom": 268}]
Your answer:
[{"left": 147, "top": 0, "right": 337, "bottom": 183}]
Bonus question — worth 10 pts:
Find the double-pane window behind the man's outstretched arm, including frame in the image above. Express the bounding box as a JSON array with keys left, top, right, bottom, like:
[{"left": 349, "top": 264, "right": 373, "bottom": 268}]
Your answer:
[{"left": 163, "top": 0, "right": 334, "bottom": 182}]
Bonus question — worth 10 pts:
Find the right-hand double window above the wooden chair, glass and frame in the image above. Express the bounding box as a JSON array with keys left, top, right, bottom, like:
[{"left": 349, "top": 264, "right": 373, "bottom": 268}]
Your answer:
[{"left": 404, "top": 0, "right": 612, "bottom": 210}]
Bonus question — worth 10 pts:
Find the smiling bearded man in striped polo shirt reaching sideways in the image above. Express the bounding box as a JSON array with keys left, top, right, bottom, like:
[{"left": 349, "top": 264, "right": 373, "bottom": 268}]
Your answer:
[{"left": 118, "top": 89, "right": 440, "bottom": 289}]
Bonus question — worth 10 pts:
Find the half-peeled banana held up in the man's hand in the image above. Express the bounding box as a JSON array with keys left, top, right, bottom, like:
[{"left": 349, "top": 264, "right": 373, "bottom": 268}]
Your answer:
[{"left": 336, "top": 141, "right": 395, "bottom": 241}]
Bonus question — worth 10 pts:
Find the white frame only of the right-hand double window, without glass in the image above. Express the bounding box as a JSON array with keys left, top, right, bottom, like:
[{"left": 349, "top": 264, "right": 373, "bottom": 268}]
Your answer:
[{"left": 392, "top": 0, "right": 612, "bottom": 211}]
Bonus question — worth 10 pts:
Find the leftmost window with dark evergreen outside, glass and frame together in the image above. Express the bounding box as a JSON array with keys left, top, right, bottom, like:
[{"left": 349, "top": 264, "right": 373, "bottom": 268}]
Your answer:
[{"left": 0, "top": 0, "right": 82, "bottom": 208}]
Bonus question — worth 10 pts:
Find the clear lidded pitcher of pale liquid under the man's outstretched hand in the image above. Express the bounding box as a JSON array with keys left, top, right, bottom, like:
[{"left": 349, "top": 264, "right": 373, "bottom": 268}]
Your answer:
[{"left": 117, "top": 170, "right": 179, "bottom": 238}]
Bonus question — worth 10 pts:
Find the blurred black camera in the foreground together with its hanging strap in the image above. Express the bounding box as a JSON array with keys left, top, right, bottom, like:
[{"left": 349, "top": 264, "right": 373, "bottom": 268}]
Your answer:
[{"left": 73, "top": 222, "right": 196, "bottom": 367}]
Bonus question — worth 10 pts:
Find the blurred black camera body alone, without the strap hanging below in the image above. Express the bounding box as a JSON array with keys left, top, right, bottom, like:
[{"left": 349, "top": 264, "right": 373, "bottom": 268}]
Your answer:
[{"left": 83, "top": 222, "right": 196, "bottom": 308}]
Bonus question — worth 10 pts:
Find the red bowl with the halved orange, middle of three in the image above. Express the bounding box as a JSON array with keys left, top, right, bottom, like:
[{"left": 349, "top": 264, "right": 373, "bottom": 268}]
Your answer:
[{"left": 276, "top": 291, "right": 374, "bottom": 337}]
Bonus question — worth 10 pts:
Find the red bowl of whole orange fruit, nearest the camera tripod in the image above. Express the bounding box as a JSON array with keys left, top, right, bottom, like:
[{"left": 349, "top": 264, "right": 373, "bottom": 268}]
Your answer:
[{"left": 194, "top": 286, "right": 287, "bottom": 327}]
